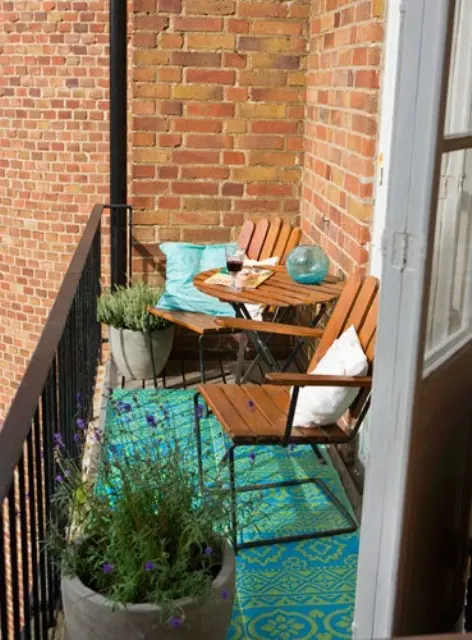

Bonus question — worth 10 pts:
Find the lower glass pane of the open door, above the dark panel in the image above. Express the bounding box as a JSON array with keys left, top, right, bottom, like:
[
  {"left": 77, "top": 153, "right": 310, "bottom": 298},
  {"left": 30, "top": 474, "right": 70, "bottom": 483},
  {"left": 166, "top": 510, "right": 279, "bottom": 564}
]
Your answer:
[{"left": 426, "top": 150, "right": 472, "bottom": 360}]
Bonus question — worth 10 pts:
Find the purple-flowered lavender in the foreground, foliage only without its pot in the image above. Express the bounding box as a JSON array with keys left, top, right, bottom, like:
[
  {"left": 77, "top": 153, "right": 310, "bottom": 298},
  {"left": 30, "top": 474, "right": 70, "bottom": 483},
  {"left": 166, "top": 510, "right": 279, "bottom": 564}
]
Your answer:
[{"left": 50, "top": 392, "right": 247, "bottom": 627}]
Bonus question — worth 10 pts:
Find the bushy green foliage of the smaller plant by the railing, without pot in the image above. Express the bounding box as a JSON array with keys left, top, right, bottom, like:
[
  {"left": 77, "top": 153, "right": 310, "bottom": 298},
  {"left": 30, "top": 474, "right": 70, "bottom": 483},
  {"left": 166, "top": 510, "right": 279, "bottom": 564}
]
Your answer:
[{"left": 97, "top": 282, "right": 170, "bottom": 331}]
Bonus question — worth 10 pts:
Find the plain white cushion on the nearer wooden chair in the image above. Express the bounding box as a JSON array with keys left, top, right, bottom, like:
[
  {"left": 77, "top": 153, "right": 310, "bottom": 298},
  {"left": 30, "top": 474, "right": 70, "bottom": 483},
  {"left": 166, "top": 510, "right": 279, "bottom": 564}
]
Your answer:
[{"left": 293, "top": 326, "right": 369, "bottom": 428}]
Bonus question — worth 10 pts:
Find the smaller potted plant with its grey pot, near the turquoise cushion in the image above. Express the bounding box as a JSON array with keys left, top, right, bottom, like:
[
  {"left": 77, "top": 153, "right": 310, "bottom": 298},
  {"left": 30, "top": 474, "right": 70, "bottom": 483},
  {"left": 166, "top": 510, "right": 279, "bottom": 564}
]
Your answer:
[{"left": 98, "top": 282, "right": 174, "bottom": 380}]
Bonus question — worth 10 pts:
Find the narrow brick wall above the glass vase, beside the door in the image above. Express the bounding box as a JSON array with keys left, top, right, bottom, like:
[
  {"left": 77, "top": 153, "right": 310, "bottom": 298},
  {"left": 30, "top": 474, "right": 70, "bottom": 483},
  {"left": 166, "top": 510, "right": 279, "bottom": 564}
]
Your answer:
[{"left": 301, "top": 0, "right": 384, "bottom": 273}]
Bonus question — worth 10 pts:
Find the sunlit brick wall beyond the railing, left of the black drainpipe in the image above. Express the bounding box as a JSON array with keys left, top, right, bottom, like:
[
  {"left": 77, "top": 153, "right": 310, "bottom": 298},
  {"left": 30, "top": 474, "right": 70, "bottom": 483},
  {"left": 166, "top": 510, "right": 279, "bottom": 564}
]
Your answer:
[{"left": 0, "top": 0, "right": 108, "bottom": 425}]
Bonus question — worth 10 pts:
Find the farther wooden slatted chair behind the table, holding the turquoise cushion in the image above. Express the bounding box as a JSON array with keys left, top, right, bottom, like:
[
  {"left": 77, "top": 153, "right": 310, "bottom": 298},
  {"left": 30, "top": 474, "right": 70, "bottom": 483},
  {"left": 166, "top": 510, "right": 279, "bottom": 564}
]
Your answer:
[{"left": 148, "top": 217, "right": 301, "bottom": 382}]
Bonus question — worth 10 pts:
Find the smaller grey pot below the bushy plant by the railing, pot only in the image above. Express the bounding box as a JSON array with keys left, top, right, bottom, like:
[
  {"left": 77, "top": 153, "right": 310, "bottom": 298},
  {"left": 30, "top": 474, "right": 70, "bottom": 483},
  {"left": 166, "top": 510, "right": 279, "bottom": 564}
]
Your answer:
[{"left": 110, "top": 325, "right": 174, "bottom": 380}]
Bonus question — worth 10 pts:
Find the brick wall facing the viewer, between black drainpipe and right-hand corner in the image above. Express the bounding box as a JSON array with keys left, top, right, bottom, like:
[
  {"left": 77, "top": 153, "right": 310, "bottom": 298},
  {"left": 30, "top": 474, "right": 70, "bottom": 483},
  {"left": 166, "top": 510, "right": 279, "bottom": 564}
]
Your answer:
[{"left": 132, "top": 0, "right": 310, "bottom": 280}]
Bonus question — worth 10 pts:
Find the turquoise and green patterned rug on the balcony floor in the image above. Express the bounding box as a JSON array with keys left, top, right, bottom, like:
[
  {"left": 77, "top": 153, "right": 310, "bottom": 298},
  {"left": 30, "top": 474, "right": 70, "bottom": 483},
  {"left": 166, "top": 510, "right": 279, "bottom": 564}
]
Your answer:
[{"left": 105, "top": 389, "right": 359, "bottom": 640}]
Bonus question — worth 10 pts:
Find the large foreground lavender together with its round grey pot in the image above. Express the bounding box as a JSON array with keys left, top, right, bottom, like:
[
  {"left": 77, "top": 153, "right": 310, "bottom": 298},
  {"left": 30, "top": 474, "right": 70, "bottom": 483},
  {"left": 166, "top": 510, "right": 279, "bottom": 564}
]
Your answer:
[{"left": 49, "top": 392, "right": 235, "bottom": 640}]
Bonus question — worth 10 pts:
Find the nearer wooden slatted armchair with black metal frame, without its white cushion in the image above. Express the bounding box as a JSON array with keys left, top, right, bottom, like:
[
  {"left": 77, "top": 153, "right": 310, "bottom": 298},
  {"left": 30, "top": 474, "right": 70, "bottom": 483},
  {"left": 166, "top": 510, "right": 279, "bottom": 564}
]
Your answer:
[{"left": 195, "top": 275, "right": 379, "bottom": 550}]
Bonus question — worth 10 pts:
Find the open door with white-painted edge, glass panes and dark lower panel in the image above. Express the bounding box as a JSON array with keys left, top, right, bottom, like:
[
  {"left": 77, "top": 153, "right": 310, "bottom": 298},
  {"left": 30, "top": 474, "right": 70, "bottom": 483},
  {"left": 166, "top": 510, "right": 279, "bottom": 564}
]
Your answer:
[{"left": 353, "top": 0, "right": 472, "bottom": 639}]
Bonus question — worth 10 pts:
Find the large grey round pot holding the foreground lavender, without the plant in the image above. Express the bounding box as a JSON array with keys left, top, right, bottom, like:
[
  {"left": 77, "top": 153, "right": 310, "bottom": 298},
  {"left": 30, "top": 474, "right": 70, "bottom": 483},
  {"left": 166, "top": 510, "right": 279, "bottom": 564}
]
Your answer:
[{"left": 61, "top": 543, "right": 236, "bottom": 640}]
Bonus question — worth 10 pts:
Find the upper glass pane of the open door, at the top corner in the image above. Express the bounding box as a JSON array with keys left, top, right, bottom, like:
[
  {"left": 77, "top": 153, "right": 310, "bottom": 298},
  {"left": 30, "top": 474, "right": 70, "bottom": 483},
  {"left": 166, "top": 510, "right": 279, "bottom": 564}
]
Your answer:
[{"left": 445, "top": 0, "right": 472, "bottom": 135}]
